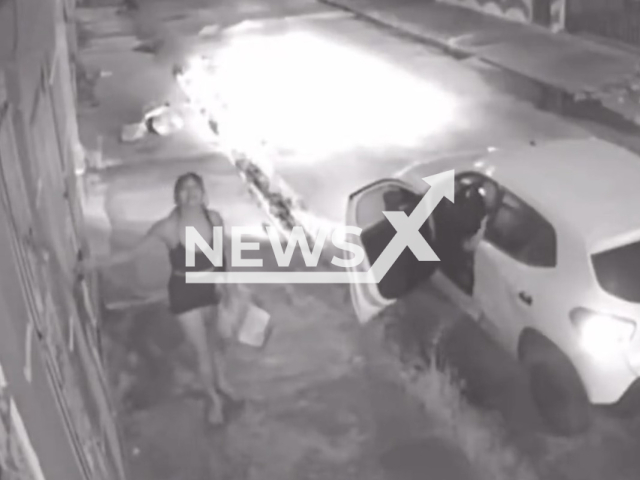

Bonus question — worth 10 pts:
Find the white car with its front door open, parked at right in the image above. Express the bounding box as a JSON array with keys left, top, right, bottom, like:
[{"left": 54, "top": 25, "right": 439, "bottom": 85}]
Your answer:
[{"left": 347, "top": 139, "right": 640, "bottom": 434}]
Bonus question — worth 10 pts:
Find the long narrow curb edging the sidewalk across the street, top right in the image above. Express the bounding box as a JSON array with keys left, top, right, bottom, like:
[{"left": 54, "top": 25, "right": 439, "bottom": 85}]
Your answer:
[{"left": 318, "top": 0, "right": 640, "bottom": 129}]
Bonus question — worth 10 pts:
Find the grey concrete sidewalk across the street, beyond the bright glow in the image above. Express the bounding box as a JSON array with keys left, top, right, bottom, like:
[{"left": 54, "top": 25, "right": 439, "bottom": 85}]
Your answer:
[{"left": 320, "top": 0, "right": 640, "bottom": 124}]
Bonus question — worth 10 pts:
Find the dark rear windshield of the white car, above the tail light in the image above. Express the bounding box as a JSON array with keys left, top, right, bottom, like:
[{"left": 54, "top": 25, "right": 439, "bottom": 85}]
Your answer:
[{"left": 591, "top": 242, "right": 640, "bottom": 302}]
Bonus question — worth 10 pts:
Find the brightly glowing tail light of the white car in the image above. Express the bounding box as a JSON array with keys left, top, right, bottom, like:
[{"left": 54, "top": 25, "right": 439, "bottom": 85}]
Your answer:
[{"left": 570, "top": 307, "right": 636, "bottom": 352}]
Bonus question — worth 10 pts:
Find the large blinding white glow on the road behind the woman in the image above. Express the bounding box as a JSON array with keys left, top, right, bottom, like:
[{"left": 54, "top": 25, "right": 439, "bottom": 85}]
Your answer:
[{"left": 182, "top": 32, "right": 455, "bottom": 156}]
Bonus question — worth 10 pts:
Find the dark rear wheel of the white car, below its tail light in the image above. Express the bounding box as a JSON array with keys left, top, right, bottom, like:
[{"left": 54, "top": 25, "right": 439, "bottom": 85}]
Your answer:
[{"left": 522, "top": 337, "right": 591, "bottom": 436}]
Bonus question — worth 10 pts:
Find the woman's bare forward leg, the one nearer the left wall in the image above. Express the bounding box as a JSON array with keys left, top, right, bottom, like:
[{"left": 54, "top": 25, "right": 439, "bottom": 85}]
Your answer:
[{"left": 178, "top": 309, "right": 222, "bottom": 423}]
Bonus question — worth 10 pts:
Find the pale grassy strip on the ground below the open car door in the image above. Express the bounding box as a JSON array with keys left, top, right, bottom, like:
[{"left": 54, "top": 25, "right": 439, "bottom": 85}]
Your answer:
[{"left": 378, "top": 301, "right": 539, "bottom": 480}]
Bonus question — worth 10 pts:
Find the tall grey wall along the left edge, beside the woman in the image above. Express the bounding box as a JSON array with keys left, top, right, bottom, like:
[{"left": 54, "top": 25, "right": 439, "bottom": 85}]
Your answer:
[{"left": 0, "top": 0, "right": 124, "bottom": 480}]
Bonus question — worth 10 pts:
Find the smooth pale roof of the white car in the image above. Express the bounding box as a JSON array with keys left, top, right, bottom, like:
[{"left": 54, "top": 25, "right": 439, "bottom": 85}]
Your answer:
[{"left": 476, "top": 138, "right": 640, "bottom": 253}]
